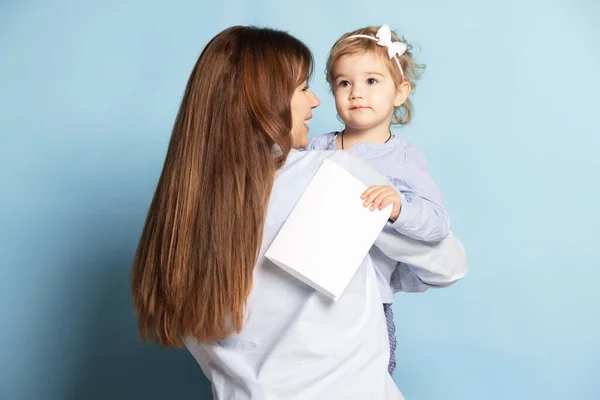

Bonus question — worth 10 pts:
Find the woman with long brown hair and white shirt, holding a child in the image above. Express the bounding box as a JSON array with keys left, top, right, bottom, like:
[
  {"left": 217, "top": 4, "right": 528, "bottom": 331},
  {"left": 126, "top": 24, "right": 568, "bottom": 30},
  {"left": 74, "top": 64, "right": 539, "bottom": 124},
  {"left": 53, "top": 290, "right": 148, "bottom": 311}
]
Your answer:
[{"left": 132, "top": 26, "right": 466, "bottom": 399}]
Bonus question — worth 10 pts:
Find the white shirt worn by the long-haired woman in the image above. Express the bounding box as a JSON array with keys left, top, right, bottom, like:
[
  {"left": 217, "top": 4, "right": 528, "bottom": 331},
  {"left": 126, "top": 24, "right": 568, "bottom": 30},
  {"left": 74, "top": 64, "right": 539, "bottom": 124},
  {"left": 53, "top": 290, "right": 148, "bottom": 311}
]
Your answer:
[{"left": 186, "top": 150, "right": 467, "bottom": 400}]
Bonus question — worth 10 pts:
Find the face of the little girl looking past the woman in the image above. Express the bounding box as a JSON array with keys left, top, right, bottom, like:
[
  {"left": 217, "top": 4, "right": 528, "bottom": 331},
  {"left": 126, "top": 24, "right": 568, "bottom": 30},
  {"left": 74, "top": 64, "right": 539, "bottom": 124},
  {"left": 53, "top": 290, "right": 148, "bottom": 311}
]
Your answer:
[{"left": 333, "top": 53, "right": 410, "bottom": 130}]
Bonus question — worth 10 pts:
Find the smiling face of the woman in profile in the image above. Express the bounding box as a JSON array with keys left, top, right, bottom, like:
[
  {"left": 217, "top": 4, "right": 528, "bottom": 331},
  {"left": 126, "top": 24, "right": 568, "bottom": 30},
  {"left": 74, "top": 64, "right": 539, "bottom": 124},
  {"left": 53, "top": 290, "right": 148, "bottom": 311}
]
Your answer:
[{"left": 291, "top": 81, "right": 321, "bottom": 149}]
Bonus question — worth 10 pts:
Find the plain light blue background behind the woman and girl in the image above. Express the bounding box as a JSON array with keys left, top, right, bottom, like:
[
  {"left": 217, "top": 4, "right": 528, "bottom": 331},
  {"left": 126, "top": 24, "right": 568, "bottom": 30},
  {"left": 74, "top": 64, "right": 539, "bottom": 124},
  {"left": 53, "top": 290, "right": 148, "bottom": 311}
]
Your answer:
[{"left": 0, "top": 0, "right": 600, "bottom": 400}]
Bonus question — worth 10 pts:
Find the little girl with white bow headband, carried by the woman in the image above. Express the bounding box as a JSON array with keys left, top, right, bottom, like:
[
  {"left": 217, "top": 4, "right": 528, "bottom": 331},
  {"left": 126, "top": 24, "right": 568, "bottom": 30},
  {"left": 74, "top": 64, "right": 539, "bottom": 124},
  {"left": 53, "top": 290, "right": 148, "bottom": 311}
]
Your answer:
[{"left": 307, "top": 25, "right": 450, "bottom": 374}]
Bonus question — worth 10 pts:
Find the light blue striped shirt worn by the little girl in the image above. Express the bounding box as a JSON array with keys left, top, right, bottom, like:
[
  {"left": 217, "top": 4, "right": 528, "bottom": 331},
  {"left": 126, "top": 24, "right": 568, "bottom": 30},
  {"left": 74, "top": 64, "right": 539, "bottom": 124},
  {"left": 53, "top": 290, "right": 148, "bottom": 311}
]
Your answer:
[{"left": 306, "top": 132, "right": 450, "bottom": 303}]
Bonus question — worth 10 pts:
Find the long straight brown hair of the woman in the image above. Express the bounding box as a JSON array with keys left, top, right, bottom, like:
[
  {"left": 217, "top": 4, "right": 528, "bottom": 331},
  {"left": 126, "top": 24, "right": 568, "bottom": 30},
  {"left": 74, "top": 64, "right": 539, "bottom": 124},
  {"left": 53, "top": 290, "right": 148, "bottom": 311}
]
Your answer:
[{"left": 131, "top": 26, "right": 313, "bottom": 347}]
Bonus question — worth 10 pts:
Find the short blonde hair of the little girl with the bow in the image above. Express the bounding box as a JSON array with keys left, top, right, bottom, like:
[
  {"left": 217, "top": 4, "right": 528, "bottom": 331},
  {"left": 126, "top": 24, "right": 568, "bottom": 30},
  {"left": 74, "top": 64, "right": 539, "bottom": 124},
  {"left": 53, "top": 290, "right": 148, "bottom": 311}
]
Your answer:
[{"left": 325, "top": 26, "right": 426, "bottom": 125}]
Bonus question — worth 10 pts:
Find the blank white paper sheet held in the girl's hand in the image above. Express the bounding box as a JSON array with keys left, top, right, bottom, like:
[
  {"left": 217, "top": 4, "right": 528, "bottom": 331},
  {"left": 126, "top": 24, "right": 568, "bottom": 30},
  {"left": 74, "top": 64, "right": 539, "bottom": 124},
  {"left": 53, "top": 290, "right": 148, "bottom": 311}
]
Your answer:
[{"left": 265, "top": 160, "right": 392, "bottom": 300}]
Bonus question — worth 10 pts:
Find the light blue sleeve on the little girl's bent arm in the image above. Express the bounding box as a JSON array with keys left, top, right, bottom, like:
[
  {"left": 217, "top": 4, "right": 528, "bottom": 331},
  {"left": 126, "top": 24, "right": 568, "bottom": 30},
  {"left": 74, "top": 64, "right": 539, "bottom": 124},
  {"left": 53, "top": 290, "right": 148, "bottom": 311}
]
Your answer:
[{"left": 390, "top": 147, "right": 450, "bottom": 242}]
